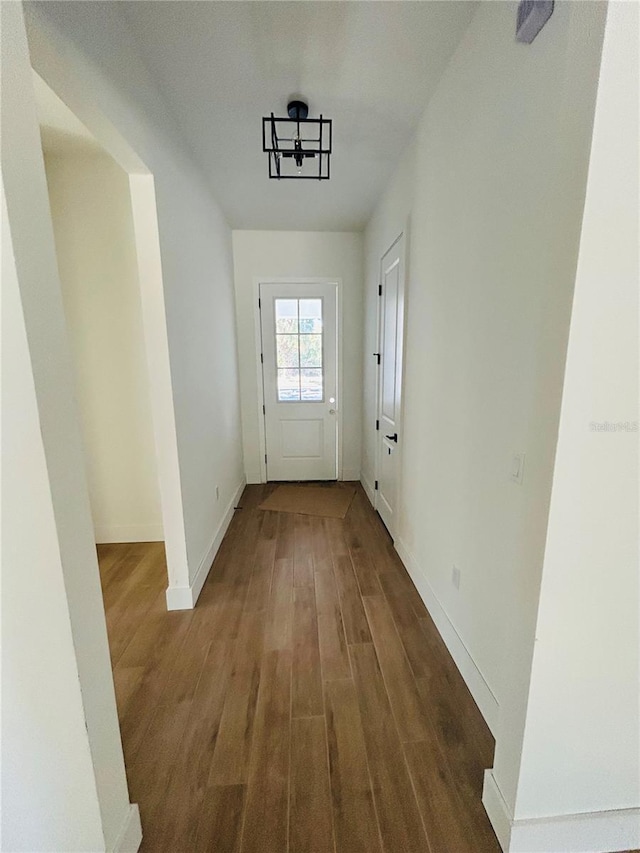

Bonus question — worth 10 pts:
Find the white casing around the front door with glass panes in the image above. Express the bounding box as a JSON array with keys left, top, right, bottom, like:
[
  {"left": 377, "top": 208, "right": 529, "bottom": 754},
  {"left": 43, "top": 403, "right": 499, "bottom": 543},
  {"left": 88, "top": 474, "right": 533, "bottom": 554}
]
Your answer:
[{"left": 253, "top": 276, "right": 344, "bottom": 483}]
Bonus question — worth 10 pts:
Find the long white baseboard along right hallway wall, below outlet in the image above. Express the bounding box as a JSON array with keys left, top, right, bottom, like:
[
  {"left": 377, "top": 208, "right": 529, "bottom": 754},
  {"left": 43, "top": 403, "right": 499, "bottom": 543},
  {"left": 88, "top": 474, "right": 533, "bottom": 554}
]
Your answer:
[{"left": 396, "top": 540, "right": 499, "bottom": 737}]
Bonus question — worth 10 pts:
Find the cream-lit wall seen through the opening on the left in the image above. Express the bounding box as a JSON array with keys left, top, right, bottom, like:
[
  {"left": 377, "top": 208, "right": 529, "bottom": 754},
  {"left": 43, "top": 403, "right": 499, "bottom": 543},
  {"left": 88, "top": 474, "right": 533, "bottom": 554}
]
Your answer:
[{"left": 45, "top": 148, "right": 163, "bottom": 542}]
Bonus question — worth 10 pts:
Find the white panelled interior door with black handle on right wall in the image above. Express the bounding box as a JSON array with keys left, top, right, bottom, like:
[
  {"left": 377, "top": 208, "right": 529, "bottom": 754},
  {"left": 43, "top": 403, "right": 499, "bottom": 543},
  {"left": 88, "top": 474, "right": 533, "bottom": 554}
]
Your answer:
[{"left": 376, "top": 236, "right": 404, "bottom": 536}]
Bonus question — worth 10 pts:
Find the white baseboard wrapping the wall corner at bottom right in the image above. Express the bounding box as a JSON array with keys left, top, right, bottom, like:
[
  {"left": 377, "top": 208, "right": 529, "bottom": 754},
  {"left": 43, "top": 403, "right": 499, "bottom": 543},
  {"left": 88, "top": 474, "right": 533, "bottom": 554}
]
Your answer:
[{"left": 482, "top": 770, "right": 640, "bottom": 853}]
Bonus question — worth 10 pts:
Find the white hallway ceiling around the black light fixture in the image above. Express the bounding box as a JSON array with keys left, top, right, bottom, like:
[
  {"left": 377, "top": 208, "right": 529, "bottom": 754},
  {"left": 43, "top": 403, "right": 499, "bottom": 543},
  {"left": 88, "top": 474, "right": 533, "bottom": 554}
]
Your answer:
[{"left": 118, "top": 0, "right": 475, "bottom": 231}]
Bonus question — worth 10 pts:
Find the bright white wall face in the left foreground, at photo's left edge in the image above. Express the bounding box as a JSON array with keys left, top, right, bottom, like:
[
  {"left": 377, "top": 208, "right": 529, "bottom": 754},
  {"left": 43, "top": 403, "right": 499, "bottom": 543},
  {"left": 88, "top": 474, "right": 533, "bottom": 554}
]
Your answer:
[{"left": 0, "top": 178, "right": 110, "bottom": 851}]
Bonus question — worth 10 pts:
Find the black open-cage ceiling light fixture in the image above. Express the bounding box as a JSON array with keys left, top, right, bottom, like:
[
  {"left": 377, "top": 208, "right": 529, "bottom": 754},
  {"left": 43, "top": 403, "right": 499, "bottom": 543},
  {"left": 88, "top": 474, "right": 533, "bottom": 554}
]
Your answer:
[{"left": 262, "top": 101, "right": 332, "bottom": 181}]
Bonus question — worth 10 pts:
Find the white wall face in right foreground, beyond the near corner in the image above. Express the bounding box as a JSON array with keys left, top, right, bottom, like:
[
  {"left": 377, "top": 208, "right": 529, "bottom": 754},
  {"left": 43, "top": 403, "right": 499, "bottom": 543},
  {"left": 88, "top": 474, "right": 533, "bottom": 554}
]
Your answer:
[{"left": 515, "top": 3, "right": 640, "bottom": 832}]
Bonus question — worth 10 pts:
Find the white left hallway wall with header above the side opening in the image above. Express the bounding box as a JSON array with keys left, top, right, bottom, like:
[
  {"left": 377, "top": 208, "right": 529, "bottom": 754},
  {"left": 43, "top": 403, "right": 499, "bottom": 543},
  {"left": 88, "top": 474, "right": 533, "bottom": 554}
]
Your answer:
[{"left": 27, "top": 2, "right": 243, "bottom": 606}]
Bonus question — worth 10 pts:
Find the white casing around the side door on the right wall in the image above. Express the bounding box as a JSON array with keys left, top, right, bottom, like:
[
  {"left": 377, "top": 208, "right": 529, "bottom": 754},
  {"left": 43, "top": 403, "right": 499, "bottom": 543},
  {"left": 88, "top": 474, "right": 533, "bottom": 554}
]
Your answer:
[{"left": 373, "top": 230, "right": 410, "bottom": 541}]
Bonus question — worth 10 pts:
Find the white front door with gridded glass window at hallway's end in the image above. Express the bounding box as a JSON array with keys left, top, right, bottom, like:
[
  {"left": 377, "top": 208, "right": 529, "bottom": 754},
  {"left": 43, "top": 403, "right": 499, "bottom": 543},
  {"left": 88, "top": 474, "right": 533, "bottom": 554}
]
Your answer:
[{"left": 260, "top": 282, "right": 338, "bottom": 480}]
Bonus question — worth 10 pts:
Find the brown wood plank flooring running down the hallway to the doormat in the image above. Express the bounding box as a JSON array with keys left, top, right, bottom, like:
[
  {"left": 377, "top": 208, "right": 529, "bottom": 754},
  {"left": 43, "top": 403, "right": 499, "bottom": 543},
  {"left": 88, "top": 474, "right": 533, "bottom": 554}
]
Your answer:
[{"left": 98, "top": 484, "right": 500, "bottom": 853}]
